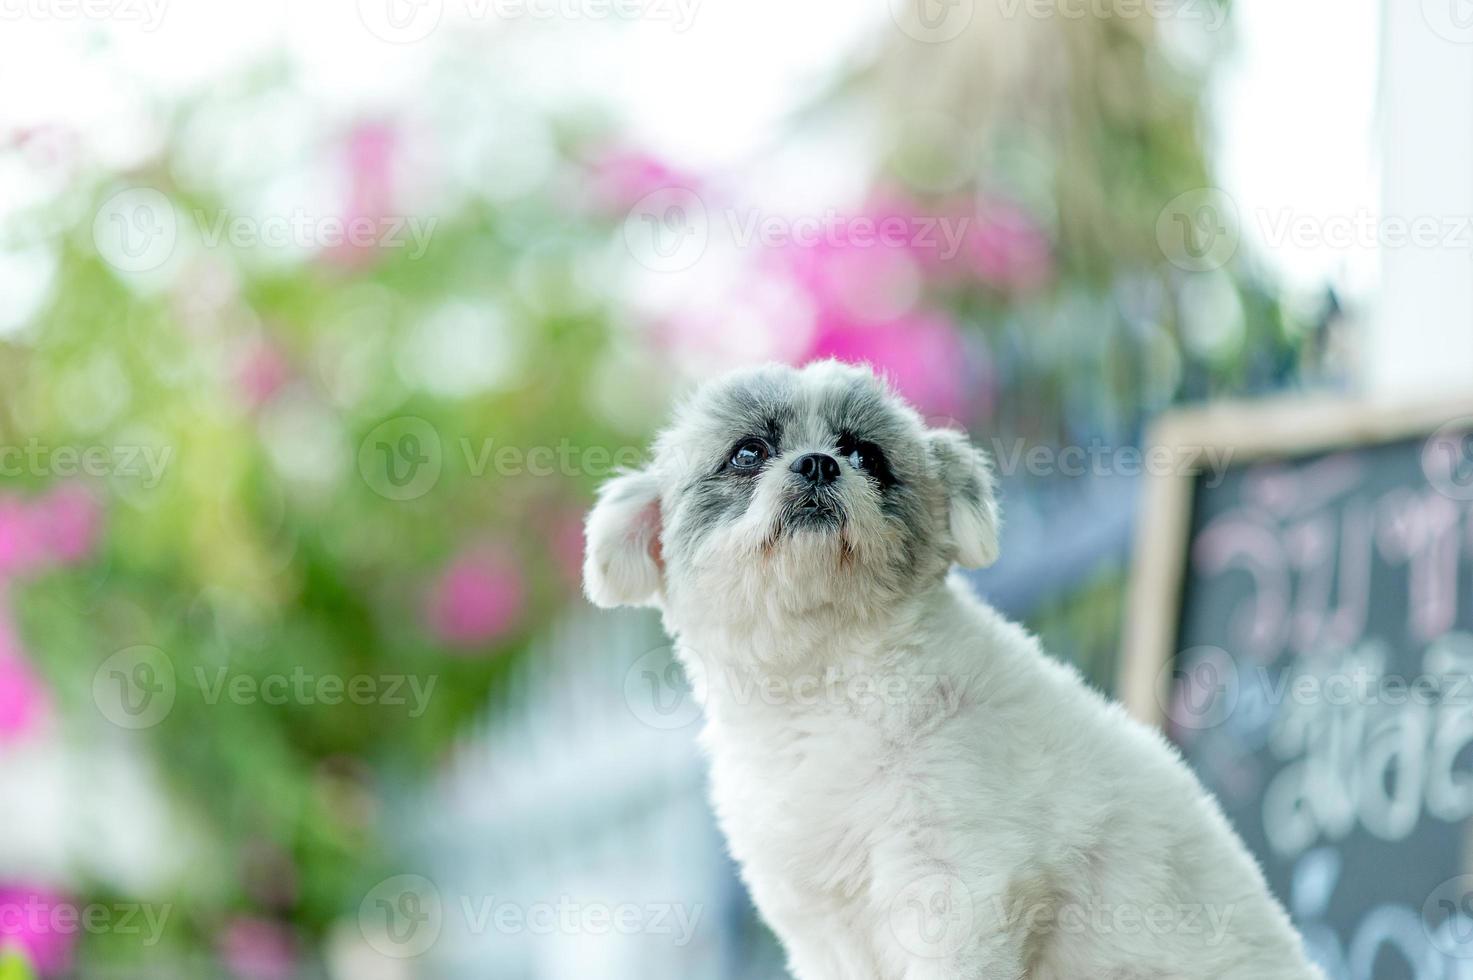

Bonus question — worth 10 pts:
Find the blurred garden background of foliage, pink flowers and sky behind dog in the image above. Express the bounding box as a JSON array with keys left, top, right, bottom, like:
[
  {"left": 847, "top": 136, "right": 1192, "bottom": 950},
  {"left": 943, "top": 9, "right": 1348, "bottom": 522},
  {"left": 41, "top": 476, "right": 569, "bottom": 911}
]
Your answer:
[{"left": 0, "top": 0, "right": 1449, "bottom": 980}]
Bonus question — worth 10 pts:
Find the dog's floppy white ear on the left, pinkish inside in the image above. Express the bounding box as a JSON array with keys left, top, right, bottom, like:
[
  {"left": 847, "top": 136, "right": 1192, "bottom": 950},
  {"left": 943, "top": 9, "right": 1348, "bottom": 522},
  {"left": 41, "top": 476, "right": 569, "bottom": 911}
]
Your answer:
[{"left": 583, "top": 470, "right": 664, "bottom": 609}]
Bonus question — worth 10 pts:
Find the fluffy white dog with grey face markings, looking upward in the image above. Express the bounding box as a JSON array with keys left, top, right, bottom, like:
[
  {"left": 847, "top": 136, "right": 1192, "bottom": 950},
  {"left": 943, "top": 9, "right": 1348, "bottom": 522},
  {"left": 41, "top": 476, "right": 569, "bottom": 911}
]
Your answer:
[{"left": 585, "top": 363, "right": 1320, "bottom": 980}]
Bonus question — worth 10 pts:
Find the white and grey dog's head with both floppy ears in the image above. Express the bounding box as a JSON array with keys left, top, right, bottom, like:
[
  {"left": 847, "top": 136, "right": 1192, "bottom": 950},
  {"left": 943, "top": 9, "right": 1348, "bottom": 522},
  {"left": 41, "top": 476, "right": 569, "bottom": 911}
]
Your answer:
[{"left": 583, "top": 361, "right": 997, "bottom": 622}]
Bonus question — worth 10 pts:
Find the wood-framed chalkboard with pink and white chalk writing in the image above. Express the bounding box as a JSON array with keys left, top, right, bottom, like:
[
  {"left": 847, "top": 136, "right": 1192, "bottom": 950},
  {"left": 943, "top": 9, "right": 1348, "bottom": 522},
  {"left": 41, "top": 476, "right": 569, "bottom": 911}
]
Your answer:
[{"left": 1121, "top": 394, "right": 1473, "bottom": 980}]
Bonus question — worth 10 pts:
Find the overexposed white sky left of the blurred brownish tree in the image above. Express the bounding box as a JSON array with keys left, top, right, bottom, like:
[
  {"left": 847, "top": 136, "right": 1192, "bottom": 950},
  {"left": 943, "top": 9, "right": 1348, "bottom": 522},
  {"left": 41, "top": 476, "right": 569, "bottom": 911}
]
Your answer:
[{"left": 0, "top": 0, "right": 888, "bottom": 169}]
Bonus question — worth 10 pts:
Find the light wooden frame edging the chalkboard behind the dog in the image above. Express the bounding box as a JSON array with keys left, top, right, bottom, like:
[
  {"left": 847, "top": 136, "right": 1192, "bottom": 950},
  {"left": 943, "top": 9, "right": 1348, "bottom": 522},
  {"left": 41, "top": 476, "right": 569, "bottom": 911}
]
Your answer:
[{"left": 1117, "top": 398, "right": 1473, "bottom": 728}]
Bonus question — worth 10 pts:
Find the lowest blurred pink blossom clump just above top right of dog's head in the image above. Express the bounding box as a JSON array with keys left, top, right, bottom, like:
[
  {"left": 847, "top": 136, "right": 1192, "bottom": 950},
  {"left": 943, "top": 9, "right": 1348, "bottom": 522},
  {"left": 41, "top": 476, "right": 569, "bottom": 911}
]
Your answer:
[{"left": 806, "top": 312, "right": 971, "bottom": 419}]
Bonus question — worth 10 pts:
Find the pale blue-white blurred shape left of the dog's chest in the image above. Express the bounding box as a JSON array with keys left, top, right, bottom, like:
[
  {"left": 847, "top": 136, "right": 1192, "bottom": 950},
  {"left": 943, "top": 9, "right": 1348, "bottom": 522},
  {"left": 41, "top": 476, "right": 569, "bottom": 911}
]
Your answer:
[{"left": 396, "top": 610, "right": 781, "bottom": 980}]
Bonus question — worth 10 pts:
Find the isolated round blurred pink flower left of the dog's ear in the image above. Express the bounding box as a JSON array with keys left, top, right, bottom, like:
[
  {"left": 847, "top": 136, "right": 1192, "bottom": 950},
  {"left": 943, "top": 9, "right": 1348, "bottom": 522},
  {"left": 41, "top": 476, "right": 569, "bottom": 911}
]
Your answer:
[{"left": 427, "top": 548, "right": 526, "bottom": 648}]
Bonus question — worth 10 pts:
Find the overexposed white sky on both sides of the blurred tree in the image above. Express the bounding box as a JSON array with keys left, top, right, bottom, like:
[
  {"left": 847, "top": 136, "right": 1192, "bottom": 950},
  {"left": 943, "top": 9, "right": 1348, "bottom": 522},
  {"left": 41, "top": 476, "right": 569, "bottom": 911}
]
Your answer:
[{"left": 0, "top": 0, "right": 1379, "bottom": 296}]
